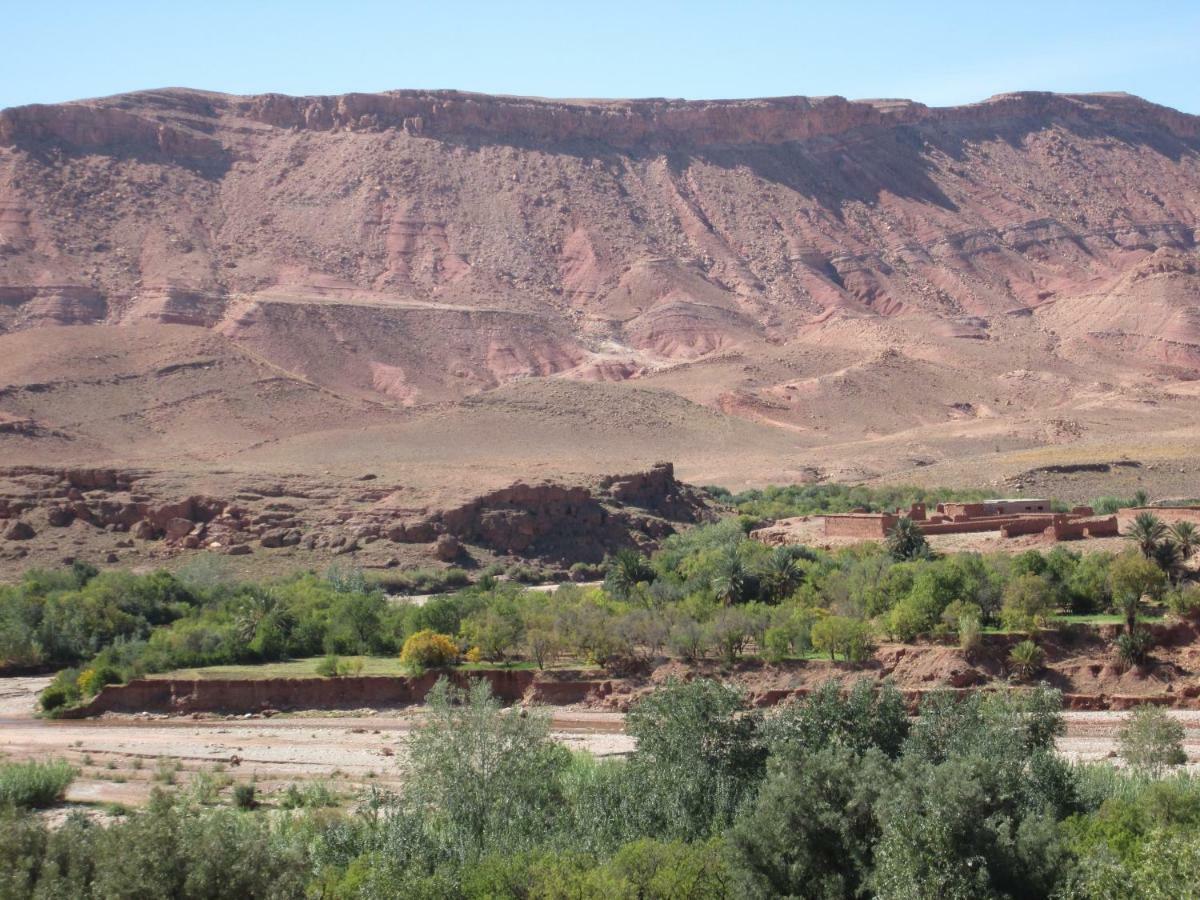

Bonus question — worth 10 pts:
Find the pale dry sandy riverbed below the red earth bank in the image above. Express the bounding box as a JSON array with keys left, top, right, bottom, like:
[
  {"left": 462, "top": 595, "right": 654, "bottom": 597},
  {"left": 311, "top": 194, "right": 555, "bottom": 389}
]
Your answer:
[{"left": 0, "top": 678, "right": 1200, "bottom": 805}]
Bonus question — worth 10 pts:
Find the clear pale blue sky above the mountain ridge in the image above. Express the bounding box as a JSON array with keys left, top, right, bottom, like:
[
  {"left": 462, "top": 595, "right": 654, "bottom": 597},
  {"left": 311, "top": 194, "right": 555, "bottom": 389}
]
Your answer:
[{"left": 0, "top": 0, "right": 1200, "bottom": 113}]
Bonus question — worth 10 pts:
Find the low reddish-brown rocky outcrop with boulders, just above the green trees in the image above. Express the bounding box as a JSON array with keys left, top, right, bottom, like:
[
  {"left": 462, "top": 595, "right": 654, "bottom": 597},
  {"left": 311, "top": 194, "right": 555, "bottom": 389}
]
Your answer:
[{"left": 0, "top": 463, "right": 714, "bottom": 566}]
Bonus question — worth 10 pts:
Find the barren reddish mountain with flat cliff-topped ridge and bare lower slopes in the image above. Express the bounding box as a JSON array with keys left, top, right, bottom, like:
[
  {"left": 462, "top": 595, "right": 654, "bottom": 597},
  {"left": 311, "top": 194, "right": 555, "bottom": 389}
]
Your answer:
[{"left": 0, "top": 89, "right": 1200, "bottom": 501}]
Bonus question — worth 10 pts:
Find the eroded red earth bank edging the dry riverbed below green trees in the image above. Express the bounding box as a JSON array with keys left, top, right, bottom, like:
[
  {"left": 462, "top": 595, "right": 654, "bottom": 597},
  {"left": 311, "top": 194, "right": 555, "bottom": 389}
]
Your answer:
[{"left": 60, "top": 622, "right": 1200, "bottom": 718}]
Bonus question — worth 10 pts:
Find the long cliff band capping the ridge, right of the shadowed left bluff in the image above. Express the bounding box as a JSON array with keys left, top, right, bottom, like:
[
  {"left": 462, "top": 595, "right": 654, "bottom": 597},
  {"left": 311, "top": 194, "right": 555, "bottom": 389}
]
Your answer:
[{"left": 233, "top": 91, "right": 1200, "bottom": 148}]
